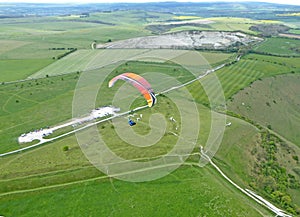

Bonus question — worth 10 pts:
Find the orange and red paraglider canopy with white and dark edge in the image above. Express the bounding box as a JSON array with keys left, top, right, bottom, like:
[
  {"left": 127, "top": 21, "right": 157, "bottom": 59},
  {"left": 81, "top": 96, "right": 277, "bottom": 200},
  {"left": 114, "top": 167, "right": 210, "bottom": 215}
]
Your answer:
[{"left": 108, "top": 72, "right": 156, "bottom": 107}]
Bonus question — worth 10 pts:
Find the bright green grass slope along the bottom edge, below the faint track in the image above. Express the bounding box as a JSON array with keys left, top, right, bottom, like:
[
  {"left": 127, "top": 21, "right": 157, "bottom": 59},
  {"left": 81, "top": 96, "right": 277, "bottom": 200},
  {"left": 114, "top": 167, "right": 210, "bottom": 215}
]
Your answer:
[{"left": 0, "top": 166, "right": 267, "bottom": 216}]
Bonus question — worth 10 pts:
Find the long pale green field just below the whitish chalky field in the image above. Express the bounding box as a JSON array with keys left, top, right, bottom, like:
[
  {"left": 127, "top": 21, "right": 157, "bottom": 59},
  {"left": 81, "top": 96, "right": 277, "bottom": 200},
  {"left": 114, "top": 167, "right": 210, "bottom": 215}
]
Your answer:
[{"left": 30, "top": 49, "right": 232, "bottom": 78}]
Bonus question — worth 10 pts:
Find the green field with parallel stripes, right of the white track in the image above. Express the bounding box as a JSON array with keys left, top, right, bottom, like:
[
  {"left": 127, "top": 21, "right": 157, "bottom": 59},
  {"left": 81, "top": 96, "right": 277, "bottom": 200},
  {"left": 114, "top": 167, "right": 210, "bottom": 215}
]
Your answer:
[{"left": 189, "top": 54, "right": 300, "bottom": 107}]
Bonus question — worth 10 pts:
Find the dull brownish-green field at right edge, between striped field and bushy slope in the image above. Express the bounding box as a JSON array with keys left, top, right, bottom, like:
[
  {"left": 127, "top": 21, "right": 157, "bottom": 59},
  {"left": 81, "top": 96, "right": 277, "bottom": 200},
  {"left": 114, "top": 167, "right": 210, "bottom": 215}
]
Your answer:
[{"left": 229, "top": 74, "right": 300, "bottom": 147}]
